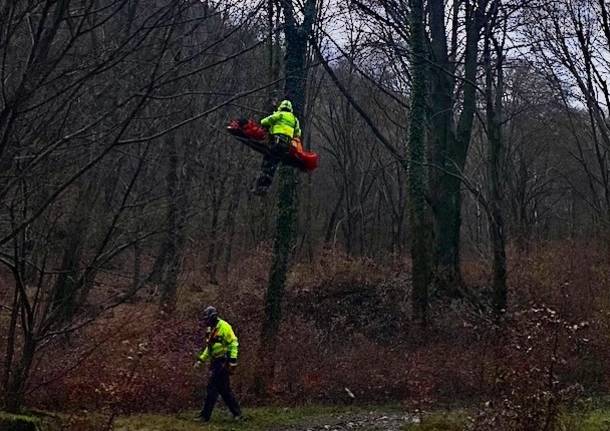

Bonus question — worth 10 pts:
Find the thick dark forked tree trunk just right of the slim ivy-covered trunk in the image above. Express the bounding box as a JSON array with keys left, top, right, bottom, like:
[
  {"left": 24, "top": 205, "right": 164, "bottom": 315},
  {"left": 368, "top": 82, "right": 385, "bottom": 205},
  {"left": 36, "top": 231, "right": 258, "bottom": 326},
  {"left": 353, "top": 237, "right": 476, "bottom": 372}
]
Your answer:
[{"left": 429, "top": 0, "right": 485, "bottom": 294}]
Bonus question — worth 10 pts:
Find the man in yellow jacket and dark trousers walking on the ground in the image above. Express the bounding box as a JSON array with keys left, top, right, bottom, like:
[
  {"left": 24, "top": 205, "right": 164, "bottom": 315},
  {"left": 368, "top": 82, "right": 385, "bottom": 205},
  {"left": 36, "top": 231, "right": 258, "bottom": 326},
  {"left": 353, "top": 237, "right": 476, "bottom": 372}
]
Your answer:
[{"left": 197, "top": 306, "right": 242, "bottom": 422}]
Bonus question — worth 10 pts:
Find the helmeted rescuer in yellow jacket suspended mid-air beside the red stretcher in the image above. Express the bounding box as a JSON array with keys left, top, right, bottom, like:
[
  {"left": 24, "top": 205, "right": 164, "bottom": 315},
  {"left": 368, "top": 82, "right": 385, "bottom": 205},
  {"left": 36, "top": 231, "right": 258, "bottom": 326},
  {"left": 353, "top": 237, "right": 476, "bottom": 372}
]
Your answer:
[{"left": 252, "top": 100, "right": 301, "bottom": 195}]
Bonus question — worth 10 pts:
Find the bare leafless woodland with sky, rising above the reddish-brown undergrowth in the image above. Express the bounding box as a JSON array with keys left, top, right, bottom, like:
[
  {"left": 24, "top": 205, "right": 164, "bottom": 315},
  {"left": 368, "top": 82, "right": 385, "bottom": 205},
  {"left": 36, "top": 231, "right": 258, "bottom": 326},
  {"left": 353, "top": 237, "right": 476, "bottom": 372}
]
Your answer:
[{"left": 0, "top": 0, "right": 610, "bottom": 429}]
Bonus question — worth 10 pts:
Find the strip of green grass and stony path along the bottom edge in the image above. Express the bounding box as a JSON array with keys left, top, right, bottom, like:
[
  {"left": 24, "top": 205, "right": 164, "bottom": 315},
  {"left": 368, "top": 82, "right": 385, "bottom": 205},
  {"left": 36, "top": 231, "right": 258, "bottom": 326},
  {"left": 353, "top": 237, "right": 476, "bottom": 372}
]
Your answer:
[{"left": 0, "top": 402, "right": 610, "bottom": 431}]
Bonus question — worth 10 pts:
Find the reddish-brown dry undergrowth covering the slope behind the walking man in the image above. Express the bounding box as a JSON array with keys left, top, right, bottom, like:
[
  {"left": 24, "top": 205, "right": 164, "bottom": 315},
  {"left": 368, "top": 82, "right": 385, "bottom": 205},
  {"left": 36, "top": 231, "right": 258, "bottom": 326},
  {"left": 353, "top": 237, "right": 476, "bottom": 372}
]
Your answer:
[{"left": 14, "top": 243, "right": 610, "bottom": 414}]
